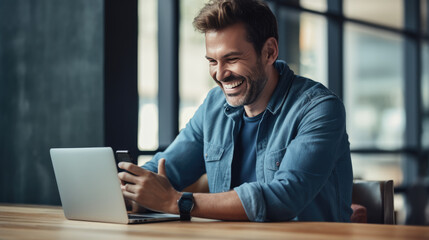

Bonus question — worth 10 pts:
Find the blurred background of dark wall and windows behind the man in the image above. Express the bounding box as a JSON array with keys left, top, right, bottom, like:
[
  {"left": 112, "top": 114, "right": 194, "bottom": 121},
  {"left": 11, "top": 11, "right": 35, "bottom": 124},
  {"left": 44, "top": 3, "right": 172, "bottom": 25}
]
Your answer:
[{"left": 0, "top": 0, "right": 429, "bottom": 225}]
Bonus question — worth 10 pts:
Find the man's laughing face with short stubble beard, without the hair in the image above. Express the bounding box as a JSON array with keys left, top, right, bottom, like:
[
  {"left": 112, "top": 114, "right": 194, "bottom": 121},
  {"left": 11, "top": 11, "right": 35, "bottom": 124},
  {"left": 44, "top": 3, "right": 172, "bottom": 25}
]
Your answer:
[{"left": 206, "top": 23, "right": 267, "bottom": 106}]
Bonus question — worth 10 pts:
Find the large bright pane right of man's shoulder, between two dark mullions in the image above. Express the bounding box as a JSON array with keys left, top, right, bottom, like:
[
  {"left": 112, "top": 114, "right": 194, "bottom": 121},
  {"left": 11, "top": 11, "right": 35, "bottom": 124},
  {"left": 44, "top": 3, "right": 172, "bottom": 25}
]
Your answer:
[{"left": 344, "top": 23, "right": 405, "bottom": 149}]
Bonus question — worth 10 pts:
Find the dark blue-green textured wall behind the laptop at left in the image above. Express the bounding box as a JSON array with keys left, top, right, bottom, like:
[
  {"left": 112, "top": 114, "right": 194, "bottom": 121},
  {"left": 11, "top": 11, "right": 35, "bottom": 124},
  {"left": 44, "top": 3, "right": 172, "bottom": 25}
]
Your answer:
[{"left": 0, "top": 0, "right": 104, "bottom": 204}]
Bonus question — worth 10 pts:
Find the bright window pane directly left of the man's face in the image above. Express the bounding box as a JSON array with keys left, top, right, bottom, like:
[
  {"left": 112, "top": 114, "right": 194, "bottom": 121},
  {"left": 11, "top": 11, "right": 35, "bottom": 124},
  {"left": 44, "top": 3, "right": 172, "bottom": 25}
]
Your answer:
[{"left": 179, "top": 0, "right": 216, "bottom": 129}]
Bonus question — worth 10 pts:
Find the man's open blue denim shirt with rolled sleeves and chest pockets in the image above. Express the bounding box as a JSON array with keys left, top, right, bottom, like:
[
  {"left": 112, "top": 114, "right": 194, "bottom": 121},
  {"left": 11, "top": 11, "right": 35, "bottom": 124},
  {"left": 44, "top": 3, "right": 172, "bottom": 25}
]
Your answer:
[{"left": 143, "top": 61, "right": 353, "bottom": 222}]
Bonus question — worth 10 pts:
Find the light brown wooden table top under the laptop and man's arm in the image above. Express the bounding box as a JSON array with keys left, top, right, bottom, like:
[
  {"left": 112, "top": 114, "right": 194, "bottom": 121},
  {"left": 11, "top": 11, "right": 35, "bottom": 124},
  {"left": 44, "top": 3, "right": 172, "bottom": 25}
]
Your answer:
[{"left": 0, "top": 204, "right": 429, "bottom": 240}]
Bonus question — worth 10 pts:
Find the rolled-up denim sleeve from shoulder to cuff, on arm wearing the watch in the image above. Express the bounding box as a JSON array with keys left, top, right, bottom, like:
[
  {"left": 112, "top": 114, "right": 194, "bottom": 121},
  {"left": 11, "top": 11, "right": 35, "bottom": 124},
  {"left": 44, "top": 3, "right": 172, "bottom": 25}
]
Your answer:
[{"left": 234, "top": 96, "right": 348, "bottom": 221}]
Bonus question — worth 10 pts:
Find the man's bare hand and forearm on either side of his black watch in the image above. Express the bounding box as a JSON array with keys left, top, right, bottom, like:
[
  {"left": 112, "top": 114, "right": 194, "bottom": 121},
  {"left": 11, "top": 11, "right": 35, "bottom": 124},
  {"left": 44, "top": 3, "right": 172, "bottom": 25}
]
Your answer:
[{"left": 118, "top": 159, "right": 248, "bottom": 220}]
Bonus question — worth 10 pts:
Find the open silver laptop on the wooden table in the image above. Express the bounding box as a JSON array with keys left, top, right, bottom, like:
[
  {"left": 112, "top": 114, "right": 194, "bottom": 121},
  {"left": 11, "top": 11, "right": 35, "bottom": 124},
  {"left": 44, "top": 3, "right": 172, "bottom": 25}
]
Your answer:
[{"left": 50, "top": 147, "right": 180, "bottom": 224}]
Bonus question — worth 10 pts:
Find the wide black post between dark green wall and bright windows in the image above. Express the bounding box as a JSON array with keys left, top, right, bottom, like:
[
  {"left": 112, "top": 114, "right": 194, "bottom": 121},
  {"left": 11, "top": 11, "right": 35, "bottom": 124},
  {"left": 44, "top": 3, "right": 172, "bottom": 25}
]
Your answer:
[{"left": 100, "top": 0, "right": 138, "bottom": 159}]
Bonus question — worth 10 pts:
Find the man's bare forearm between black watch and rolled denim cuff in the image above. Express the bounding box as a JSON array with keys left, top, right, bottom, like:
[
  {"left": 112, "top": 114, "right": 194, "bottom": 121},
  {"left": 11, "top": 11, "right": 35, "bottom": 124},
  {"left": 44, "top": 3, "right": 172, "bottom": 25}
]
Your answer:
[{"left": 191, "top": 191, "right": 249, "bottom": 221}]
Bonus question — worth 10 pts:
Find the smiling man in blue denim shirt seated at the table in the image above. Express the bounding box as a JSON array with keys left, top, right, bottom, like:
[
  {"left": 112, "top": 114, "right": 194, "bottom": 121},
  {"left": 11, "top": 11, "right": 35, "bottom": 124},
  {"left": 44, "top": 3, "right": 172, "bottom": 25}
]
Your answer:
[{"left": 119, "top": 0, "right": 353, "bottom": 222}]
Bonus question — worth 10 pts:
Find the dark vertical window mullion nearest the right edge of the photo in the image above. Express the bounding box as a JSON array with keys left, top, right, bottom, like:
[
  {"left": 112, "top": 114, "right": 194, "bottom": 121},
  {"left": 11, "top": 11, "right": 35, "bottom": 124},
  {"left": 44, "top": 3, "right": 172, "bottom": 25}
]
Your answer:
[{"left": 403, "top": 0, "right": 427, "bottom": 224}]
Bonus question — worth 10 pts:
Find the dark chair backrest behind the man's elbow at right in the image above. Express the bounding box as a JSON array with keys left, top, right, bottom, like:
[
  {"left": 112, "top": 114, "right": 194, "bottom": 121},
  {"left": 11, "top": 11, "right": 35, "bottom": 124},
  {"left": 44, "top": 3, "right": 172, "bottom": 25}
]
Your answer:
[{"left": 352, "top": 180, "right": 395, "bottom": 224}]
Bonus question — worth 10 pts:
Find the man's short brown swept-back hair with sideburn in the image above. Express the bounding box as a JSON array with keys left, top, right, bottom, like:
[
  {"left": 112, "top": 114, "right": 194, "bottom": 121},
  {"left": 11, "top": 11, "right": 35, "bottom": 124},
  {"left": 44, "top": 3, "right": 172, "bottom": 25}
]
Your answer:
[{"left": 193, "top": 0, "right": 279, "bottom": 55}]
